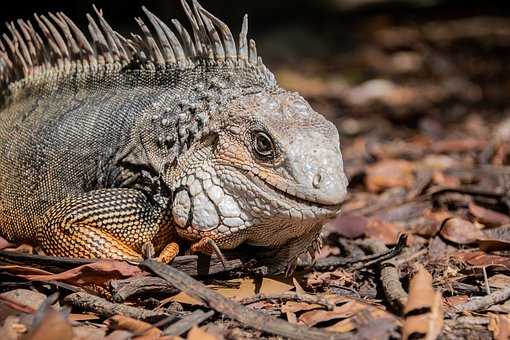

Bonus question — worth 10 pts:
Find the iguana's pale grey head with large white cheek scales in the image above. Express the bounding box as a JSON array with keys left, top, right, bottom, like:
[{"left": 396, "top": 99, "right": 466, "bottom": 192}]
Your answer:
[{"left": 169, "top": 86, "right": 347, "bottom": 262}]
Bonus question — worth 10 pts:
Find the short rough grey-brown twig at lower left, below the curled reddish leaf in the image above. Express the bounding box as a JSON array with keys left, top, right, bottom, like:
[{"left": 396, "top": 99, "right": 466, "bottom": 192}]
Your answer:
[{"left": 64, "top": 292, "right": 176, "bottom": 322}]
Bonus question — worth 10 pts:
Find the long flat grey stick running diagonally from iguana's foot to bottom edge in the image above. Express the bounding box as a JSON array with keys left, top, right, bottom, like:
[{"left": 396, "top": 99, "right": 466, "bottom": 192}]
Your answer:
[{"left": 140, "top": 260, "right": 350, "bottom": 340}]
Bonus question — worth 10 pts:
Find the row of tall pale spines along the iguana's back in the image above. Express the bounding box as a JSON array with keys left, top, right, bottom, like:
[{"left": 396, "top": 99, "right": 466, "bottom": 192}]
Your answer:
[{"left": 0, "top": 0, "right": 274, "bottom": 89}]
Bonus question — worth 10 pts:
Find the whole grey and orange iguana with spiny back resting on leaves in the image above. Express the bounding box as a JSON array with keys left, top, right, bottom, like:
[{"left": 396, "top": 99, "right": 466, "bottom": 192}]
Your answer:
[{"left": 0, "top": 0, "right": 347, "bottom": 266}]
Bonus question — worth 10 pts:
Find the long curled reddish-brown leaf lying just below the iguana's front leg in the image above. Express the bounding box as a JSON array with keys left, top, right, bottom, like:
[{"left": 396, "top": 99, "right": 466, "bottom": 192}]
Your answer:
[{"left": 17, "top": 260, "right": 144, "bottom": 286}]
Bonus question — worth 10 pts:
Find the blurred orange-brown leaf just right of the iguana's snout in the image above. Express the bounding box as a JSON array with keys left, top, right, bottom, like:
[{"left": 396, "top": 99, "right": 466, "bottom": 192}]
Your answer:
[{"left": 365, "top": 159, "right": 414, "bottom": 193}]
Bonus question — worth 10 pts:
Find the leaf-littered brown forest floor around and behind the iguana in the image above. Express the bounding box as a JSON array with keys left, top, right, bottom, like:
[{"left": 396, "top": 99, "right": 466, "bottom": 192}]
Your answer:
[{"left": 0, "top": 4, "right": 510, "bottom": 340}]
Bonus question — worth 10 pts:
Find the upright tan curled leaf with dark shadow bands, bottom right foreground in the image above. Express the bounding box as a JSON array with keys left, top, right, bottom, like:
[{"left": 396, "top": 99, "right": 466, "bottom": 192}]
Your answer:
[{"left": 402, "top": 264, "right": 443, "bottom": 340}]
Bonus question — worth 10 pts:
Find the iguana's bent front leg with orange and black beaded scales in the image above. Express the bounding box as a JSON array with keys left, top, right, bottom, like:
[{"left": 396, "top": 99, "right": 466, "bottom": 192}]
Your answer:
[{"left": 37, "top": 189, "right": 175, "bottom": 262}]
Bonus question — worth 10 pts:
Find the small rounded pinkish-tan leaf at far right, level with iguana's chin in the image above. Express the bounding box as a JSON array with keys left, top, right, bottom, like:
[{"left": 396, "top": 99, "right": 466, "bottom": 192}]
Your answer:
[{"left": 439, "top": 217, "right": 485, "bottom": 244}]
